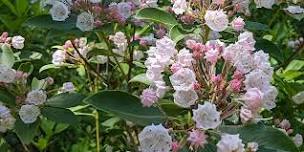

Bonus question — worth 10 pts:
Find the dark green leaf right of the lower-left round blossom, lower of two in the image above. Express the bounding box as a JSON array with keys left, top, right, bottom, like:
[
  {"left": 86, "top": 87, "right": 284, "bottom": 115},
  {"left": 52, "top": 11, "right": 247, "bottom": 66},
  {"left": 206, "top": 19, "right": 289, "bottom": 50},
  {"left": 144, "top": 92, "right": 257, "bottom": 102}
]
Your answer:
[{"left": 41, "top": 106, "right": 78, "bottom": 125}]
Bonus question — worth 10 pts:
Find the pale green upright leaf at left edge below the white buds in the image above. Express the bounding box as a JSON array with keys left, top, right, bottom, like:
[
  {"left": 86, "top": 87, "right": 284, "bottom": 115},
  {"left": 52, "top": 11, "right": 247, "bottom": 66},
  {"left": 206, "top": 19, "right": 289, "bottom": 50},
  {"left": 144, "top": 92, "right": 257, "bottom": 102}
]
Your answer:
[{"left": 0, "top": 44, "right": 15, "bottom": 67}]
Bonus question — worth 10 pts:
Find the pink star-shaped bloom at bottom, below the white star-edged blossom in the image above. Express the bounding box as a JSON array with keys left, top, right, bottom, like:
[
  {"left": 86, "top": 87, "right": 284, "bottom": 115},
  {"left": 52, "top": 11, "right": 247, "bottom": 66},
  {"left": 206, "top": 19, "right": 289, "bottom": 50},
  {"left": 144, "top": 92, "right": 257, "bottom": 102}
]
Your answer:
[{"left": 187, "top": 129, "right": 208, "bottom": 149}]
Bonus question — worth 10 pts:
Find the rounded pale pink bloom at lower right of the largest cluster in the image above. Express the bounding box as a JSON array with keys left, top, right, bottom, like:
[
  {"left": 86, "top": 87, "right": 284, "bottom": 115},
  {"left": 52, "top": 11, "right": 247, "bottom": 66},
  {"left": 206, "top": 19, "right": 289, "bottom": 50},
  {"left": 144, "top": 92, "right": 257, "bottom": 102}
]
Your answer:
[{"left": 243, "top": 88, "right": 263, "bottom": 111}]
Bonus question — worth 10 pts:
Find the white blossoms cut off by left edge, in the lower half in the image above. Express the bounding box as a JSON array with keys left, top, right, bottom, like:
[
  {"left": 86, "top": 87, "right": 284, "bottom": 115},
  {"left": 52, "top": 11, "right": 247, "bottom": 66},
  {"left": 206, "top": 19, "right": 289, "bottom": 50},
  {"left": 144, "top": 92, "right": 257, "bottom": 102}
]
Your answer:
[{"left": 0, "top": 103, "right": 16, "bottom": 132}]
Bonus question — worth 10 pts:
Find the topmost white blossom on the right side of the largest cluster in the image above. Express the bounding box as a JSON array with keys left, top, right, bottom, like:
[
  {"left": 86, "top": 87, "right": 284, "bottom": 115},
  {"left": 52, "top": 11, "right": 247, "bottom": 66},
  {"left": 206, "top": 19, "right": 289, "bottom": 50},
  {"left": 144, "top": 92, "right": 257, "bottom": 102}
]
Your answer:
[{"left": 237, "top": 31, "right": 255, "bottom": 51}]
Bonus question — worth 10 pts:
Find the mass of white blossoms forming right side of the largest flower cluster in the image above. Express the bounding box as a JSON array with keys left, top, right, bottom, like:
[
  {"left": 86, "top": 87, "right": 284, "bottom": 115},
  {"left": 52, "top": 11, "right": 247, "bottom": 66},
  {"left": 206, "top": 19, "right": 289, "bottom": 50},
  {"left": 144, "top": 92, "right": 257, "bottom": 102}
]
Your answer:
[{"left": 222, "top": 32, "right": 278, "bottom": 109}]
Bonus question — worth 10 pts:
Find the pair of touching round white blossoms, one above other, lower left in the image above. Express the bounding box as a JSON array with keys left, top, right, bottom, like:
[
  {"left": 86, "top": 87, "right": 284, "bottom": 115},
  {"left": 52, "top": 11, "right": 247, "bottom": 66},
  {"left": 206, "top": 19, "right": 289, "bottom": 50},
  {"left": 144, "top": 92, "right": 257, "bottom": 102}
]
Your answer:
[{"left": 19, "top": 90, "right": 47, "bottom": 124}]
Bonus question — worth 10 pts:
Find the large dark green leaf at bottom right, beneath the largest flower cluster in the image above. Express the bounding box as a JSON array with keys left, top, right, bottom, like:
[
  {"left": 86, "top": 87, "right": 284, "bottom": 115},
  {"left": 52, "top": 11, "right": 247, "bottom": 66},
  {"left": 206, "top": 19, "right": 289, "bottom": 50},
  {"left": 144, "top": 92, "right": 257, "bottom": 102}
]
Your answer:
[{"left": 220, "top": 124, "right": 299, "bottom": 152}]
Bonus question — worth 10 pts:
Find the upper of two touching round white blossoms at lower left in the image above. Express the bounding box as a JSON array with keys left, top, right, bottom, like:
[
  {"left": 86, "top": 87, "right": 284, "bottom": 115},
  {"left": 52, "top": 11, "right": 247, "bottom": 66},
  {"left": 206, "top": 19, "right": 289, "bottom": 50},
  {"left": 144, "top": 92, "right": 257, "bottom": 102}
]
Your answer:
[{"left": 25, "top": 90, "right": 47, "bottom": 105}]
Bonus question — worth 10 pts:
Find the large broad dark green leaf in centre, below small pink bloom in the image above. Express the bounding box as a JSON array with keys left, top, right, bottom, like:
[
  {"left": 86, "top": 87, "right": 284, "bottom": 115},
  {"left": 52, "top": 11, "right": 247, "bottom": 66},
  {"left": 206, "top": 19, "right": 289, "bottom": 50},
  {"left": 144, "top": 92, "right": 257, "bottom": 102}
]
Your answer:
[{"left": 84, "top": 91, "right": 165, "bottom": 126}]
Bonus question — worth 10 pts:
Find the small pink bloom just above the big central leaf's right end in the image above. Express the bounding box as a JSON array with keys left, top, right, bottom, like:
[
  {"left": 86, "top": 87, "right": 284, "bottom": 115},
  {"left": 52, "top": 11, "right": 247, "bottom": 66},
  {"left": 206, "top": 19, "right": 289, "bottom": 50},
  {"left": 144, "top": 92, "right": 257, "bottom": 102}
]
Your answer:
[{"left": 140, "top": 88, "right": 158, "bottom": 107}]
